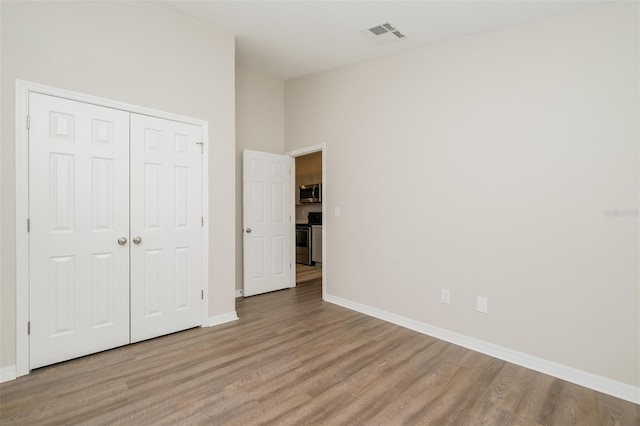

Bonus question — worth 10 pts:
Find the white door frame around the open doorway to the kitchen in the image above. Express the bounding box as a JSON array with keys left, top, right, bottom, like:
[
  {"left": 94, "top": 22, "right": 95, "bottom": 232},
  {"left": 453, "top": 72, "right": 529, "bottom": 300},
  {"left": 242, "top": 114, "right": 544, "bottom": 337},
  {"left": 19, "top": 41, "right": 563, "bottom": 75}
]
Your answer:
[{"left": 285, "top": 143, "right": 328, "bottom": 300}]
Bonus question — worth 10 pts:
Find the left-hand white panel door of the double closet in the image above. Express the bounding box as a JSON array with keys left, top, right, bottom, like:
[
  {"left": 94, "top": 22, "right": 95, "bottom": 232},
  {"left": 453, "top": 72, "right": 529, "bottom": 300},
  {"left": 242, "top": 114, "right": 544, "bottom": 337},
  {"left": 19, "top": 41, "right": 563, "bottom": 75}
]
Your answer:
[{"left": 29, "top": 93, "right": 129, "bottom": 368}]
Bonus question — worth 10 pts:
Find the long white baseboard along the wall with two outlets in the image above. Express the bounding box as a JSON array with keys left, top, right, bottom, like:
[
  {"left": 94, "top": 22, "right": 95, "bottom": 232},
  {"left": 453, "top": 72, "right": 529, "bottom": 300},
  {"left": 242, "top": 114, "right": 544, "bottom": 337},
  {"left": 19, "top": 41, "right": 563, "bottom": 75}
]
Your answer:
[{"left": 324, "top": 294, "right": 640, "bottom": 404}]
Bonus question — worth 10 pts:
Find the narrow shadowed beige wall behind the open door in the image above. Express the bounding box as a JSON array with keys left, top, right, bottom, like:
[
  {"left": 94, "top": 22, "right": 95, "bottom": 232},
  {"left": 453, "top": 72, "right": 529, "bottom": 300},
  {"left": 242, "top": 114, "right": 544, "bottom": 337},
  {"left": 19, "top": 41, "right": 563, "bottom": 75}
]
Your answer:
[{"left": 234, "top": 63, "right": 284, "bottom": 290}]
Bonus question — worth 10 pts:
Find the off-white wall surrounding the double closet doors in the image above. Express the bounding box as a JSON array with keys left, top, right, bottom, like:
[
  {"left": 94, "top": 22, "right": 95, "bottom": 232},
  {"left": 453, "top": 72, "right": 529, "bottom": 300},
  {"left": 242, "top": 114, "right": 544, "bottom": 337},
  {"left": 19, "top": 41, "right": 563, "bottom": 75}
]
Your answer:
[{"left": 0, "top": 1, "right": 236, "bottom": 367}]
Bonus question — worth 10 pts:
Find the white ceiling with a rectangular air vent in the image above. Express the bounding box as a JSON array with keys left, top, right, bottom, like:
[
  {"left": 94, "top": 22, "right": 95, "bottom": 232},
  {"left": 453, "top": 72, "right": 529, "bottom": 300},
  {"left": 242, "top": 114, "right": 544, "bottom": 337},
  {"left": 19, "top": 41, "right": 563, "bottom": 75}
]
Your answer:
[{"left": 165, "top": 0, "right": 600, "bottom": 80}]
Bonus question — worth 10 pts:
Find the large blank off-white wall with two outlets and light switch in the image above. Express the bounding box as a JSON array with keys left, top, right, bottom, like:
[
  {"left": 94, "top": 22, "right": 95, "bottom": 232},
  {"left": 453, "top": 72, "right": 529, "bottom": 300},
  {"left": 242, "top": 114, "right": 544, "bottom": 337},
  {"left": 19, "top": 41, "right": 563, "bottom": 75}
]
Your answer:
[{"left": 285, "top": 2, "right": 640, "bottom": 387}]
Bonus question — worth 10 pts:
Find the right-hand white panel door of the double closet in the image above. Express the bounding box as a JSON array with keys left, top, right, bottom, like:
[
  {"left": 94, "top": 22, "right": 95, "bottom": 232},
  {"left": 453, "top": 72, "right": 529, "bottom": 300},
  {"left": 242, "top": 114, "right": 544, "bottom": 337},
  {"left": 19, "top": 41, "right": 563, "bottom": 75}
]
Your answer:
[{"left": 131, "top": 114, "right": 203, "bottom": 342}]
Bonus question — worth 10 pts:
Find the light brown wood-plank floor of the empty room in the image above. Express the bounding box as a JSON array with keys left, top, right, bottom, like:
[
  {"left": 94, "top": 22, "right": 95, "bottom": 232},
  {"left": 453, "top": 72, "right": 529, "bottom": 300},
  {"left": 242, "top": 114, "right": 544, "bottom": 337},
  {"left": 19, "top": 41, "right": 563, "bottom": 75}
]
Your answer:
[{"left": 0, "top": 280, "right": 640, "bottom": 426}]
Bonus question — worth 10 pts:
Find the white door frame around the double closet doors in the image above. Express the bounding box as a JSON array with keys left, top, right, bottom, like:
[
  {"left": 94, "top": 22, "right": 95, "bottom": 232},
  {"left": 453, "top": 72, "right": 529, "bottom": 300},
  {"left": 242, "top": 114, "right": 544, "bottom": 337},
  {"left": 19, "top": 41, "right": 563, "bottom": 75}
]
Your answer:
[{"left": 15, "top": 80, "right": 209, "bottom": 377}]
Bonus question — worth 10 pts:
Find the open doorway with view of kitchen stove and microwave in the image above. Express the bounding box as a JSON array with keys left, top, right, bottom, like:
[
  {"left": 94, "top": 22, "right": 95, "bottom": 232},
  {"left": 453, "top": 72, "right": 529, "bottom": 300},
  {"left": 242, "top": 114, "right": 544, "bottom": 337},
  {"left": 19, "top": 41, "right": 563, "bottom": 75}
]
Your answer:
[{"left": 287, "top": 145, "right": 326, "bottom": 296}]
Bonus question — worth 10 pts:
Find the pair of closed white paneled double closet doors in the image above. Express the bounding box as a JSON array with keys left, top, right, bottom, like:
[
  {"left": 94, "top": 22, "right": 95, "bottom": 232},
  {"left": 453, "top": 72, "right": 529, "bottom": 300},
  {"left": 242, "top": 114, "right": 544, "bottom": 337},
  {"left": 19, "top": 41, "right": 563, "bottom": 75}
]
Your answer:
[{"left": 29, "top": 93, "right": 202, "bottom": 368}]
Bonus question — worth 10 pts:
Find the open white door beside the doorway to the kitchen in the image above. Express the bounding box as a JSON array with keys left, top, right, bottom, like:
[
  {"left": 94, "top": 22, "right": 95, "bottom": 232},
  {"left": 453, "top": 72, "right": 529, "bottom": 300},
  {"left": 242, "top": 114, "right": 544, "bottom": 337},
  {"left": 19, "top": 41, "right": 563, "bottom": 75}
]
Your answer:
[{"left": 242, "top": 150, "right": 292, "bottom": 296}]
